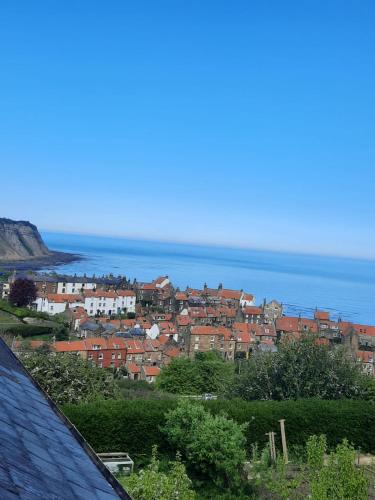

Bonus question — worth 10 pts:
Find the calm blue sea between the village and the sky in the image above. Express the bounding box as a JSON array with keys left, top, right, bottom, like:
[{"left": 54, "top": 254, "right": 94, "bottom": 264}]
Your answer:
[{"left": 42, "top": 232, "right": 375, "bottom": 325}]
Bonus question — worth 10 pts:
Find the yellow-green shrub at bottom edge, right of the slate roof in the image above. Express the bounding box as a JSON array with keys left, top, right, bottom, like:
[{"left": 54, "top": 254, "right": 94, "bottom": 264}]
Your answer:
[{"left": 120, "top": 446, "right": 195, "bottom": 500}]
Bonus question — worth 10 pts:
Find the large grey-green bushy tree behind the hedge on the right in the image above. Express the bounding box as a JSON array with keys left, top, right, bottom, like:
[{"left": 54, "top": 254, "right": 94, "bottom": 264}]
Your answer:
[{"left": 232, "top": 334, "right": 366, "bottom": 400}]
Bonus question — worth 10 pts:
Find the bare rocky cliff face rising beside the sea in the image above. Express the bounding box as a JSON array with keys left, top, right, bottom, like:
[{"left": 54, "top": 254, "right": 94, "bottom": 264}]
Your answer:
[{"left": 0, "top": 218, "right": 51, "bottom": 261}]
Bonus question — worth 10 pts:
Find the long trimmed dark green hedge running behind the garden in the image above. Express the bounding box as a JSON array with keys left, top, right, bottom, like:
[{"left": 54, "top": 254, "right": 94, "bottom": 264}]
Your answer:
[{"left": 63, "top": 400, "right": 375, "bottom": 457}]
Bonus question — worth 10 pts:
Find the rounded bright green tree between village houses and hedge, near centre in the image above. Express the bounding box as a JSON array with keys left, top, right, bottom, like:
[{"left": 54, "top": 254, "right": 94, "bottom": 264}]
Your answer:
[{"left": 156, "top": 352, "right": 234, "bottom": 395}]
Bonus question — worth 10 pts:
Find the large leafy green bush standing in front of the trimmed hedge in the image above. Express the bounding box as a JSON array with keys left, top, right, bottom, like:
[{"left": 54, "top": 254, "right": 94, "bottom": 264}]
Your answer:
[{"left": 163, "top": 401, "right": 246, "bottom": 490}]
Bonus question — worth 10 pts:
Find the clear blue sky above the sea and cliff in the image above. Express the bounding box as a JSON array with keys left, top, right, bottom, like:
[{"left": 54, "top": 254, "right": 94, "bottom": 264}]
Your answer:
[{"left": 0, "top": 0, "right": 375, "bottom": 258}]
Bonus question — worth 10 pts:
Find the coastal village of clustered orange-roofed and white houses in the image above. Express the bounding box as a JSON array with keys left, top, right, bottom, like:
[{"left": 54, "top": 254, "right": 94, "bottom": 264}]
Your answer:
[{"left": 1, "top": 271, "right": 375, "bottom": 383}]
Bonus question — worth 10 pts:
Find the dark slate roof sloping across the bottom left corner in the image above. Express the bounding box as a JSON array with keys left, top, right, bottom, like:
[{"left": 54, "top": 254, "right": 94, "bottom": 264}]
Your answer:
[{"left": 0, "top": 339, "right": 130, "bottom": 500}]
